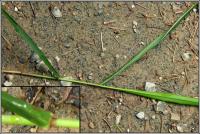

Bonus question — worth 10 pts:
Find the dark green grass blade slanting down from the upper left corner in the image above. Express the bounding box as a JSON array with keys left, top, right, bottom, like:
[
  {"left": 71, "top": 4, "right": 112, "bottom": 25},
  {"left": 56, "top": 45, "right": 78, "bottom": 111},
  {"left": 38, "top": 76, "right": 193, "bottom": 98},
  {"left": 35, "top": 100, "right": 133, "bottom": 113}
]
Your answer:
[{"left": 1, "top": 7, "right": 60, "bottom": 78}]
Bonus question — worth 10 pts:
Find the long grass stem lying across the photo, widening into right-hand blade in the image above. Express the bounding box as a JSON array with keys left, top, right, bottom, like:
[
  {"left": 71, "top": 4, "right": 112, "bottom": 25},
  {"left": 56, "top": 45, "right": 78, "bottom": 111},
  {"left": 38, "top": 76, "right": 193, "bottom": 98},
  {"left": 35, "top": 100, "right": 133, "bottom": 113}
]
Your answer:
[{"left": 2, "top": 70, "right": 199, "bottom": 106}]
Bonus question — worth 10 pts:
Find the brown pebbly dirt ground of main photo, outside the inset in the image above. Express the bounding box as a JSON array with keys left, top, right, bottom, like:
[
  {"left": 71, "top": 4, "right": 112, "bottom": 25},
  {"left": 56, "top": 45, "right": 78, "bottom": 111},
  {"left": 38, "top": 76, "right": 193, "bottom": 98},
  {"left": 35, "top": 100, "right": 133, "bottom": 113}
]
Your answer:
[{"left": 2, "top": 2, "right": 199, "bottom": 132}]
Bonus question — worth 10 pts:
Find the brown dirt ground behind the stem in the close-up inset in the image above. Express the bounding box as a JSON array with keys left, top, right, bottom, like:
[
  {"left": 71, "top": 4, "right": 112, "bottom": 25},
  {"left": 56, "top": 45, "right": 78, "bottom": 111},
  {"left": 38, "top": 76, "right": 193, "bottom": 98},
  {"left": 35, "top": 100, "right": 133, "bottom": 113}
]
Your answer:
[{"left": 2, "top": 87, "right": 80, "bottom": 133}]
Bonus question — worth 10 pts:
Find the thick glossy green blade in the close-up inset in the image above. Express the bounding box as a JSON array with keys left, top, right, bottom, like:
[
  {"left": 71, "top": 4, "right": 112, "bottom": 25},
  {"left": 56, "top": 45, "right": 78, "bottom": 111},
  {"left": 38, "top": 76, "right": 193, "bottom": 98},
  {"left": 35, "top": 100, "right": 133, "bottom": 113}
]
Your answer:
[{"left": 1, "top": 91, "right": 52, "bottom": 127}]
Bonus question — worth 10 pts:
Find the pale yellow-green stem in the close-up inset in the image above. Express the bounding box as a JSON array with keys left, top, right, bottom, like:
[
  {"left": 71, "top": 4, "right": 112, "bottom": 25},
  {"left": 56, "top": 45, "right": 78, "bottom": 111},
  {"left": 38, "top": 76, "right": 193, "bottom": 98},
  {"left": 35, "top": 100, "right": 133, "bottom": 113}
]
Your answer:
[{"left": 2, "top": 115, "right": 80, "bottom": 128}]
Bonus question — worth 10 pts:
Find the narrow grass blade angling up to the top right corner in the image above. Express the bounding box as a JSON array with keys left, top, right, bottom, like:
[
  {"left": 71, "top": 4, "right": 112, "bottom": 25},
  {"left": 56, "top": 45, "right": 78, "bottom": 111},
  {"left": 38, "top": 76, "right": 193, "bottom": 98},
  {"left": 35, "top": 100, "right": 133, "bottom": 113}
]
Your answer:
[{"left": 101, "top": 4, "right": 198, "bottom": 85}]
